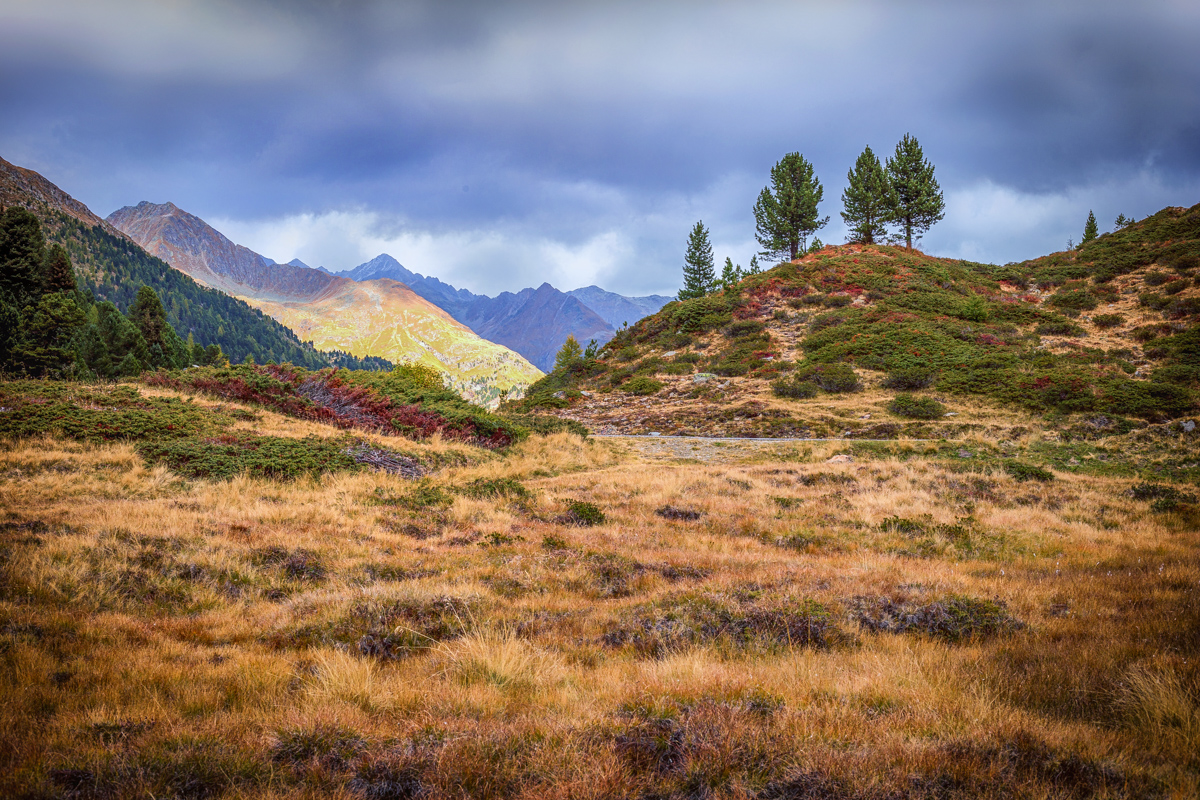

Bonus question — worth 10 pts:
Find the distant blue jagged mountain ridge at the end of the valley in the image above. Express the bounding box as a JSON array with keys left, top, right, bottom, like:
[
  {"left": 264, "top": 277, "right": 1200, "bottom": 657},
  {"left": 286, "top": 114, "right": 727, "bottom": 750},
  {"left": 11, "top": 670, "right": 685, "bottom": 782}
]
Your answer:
[{"left": 337, "top": 253, "right": 671, "bottom": 371}]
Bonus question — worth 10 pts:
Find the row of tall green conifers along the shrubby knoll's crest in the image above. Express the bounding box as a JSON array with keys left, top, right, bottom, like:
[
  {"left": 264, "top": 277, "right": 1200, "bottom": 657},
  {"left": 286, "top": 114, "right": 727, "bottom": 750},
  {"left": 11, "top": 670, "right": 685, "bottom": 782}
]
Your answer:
[{"left": 678, "top": 133, "right": 946, "bottom": 300}]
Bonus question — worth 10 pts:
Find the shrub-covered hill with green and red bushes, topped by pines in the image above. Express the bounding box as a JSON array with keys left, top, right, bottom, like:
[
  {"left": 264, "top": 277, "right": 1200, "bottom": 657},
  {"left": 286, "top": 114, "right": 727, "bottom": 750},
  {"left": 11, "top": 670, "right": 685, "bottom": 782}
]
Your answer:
[{"left": 524, "top": 199, "right": 1200, "bottom": 438}]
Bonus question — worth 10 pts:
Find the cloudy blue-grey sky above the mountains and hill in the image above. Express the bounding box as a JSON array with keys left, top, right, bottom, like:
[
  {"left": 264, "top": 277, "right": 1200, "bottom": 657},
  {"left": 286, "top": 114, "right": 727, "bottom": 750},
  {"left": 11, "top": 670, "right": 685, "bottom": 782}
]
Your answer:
[{"left": 0, "top": 0, "right": 1200, "bottom": 294}]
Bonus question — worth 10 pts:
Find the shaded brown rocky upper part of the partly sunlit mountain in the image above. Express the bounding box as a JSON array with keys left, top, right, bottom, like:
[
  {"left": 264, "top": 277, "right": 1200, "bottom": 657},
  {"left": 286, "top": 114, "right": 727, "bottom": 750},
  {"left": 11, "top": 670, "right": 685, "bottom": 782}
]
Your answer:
[{"left": 108, "top": 200, "right": 346, "bottom": 302}]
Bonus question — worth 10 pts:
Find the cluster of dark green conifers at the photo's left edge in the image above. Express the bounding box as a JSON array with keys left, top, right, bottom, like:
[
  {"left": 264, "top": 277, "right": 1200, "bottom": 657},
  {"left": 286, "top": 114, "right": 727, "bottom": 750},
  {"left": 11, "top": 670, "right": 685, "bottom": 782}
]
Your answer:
[{"left": 0, "top": 207, "right": 226, "bottom": 379}]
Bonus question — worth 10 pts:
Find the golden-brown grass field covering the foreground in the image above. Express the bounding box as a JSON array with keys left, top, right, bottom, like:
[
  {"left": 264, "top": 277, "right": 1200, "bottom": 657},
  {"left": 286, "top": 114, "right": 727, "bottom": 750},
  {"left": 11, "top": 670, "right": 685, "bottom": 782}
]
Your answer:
[{"left": 0, "top": 390, "right": 1200, "bottom": 800}]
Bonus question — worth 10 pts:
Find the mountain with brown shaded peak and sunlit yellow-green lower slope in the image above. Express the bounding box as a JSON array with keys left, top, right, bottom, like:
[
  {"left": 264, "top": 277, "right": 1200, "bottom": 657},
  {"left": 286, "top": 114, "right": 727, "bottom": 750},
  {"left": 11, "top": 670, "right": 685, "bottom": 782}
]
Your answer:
[{"left": 108, "top": 203, "right": 541, "bottom": 403}]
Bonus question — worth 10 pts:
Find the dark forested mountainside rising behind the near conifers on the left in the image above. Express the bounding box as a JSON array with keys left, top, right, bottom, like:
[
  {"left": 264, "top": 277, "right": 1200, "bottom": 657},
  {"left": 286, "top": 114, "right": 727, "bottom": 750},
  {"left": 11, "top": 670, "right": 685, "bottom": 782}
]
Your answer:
[{"left": 0, "top": 158, "right": 350, "bottom": 368}]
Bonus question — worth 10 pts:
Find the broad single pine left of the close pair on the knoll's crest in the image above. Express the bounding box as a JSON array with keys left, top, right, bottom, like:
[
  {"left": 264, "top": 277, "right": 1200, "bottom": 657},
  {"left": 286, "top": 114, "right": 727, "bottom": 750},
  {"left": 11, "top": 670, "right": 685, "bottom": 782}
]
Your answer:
[{"left": 754, "top": 152, "right": 829, "bottom": 260}]
